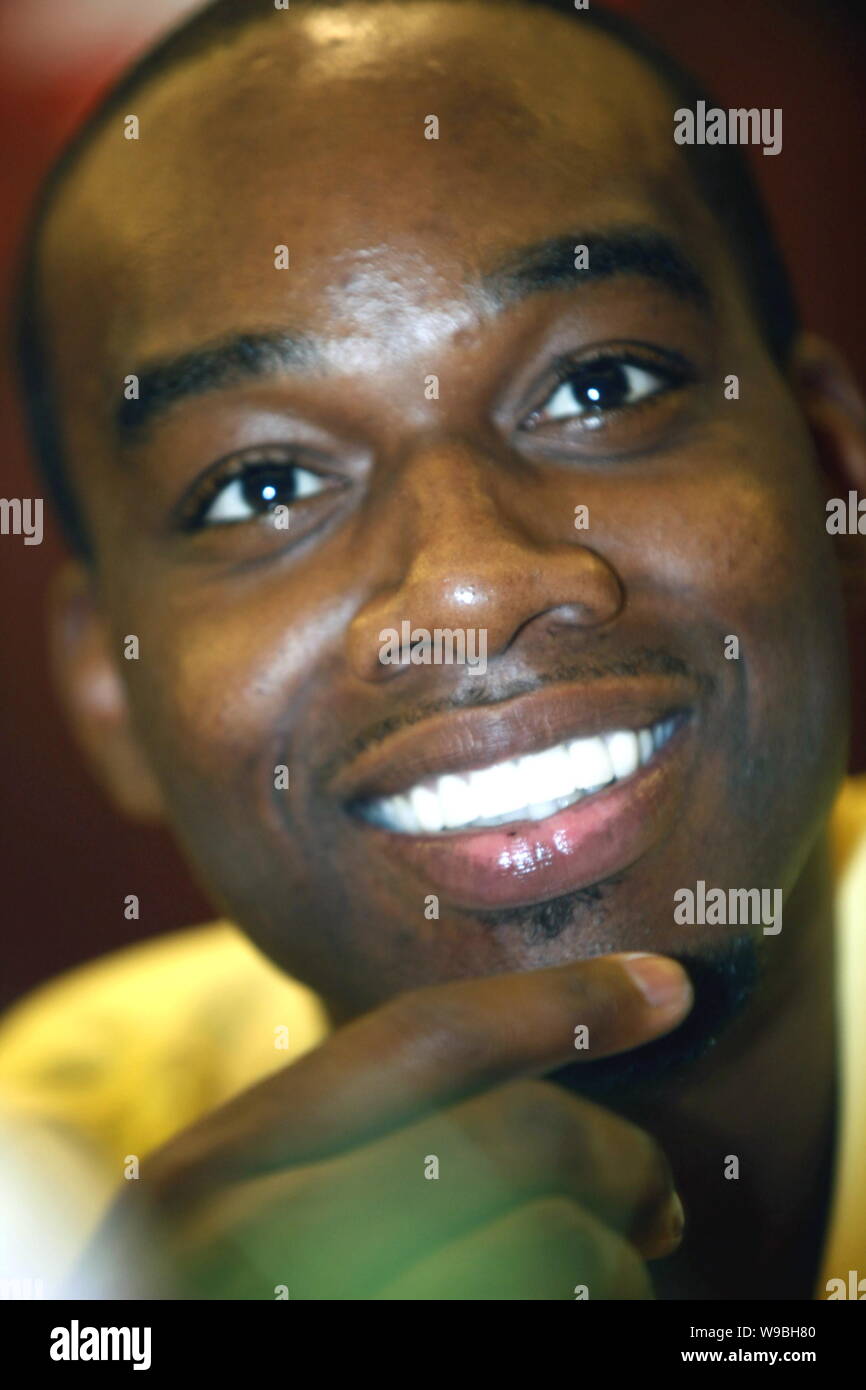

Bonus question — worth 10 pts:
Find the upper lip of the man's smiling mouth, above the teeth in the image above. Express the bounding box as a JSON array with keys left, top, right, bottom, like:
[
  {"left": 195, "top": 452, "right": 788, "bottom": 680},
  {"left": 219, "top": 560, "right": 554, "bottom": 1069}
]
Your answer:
[{"left": 331, "top": 676, "right": 695, "bottom": 803}]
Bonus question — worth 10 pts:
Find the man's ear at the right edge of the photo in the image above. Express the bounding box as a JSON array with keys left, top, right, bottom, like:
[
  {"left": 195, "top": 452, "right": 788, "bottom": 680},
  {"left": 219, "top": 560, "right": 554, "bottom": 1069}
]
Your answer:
[{"left": 791, "top": 334, "right": 866, "bottom": 609}]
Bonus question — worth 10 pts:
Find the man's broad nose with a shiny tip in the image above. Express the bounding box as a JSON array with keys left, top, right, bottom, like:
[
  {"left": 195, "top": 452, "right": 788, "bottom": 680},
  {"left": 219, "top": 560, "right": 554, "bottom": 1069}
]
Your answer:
[{"left": 348, "top": 439, "right": 624, "bottom": 682}]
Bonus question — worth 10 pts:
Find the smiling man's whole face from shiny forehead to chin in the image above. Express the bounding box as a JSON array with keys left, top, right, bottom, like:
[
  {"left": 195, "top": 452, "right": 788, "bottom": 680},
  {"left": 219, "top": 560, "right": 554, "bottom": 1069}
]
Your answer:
[{"left": 38, "top": 4, "right": 845, "bottom": 1012}]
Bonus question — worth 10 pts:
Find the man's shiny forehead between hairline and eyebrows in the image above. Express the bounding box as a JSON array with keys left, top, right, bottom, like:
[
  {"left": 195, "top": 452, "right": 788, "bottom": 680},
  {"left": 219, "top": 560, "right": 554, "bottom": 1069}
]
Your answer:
[{"left": 43, "top": 4, "right": 706, "bottom": 377}]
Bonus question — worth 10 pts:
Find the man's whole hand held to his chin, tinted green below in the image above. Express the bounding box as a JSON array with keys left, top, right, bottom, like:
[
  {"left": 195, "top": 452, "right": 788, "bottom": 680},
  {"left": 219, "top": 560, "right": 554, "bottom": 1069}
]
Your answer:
[{"left": 77, "top": 955, "right": 692, "bottom": 1301}]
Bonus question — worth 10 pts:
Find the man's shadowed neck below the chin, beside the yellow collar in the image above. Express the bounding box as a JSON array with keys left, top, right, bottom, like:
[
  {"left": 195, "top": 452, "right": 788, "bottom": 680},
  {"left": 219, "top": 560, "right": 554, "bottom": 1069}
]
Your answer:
[{"left": 631, "top": 842, "right": 837, "bottom": 1300}]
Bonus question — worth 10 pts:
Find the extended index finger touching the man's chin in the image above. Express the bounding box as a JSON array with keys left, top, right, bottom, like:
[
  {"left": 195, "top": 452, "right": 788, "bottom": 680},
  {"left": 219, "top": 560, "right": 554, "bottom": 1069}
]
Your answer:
[{"left": 147, "top": 954, "right": 692, "bottom": 1188}]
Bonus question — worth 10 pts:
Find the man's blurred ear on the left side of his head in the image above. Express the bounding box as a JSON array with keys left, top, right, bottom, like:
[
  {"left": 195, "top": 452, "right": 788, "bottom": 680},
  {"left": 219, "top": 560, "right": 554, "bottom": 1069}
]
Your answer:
[{"left": 50, "top": 562, "right": 164, "bottom": 823}]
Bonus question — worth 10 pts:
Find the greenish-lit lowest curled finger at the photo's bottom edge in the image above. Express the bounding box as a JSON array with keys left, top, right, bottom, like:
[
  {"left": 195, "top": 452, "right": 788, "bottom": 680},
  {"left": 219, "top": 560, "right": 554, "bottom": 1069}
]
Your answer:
[{"left": 375, "top": 1197, "right": 652, "bottom": 1301}]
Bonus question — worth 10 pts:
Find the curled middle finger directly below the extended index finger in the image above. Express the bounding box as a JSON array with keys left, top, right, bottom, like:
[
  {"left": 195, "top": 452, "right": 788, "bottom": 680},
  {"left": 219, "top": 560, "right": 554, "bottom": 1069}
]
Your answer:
[{"left": 174, "top": 1080, "right": 680, "bottom": 1298}]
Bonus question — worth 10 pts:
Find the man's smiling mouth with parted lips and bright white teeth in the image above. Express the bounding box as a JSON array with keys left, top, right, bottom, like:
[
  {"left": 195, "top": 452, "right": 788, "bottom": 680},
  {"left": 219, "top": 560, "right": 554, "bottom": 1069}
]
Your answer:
[{"left": 331, "top": 673, "right": 703, "bottom": 910}]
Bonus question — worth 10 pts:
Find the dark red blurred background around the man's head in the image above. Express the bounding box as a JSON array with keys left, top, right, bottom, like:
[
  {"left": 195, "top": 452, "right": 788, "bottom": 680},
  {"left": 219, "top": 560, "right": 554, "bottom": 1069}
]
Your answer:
[{"left": 0, "top": 0, "right": 866, "bottom": 1008}]
